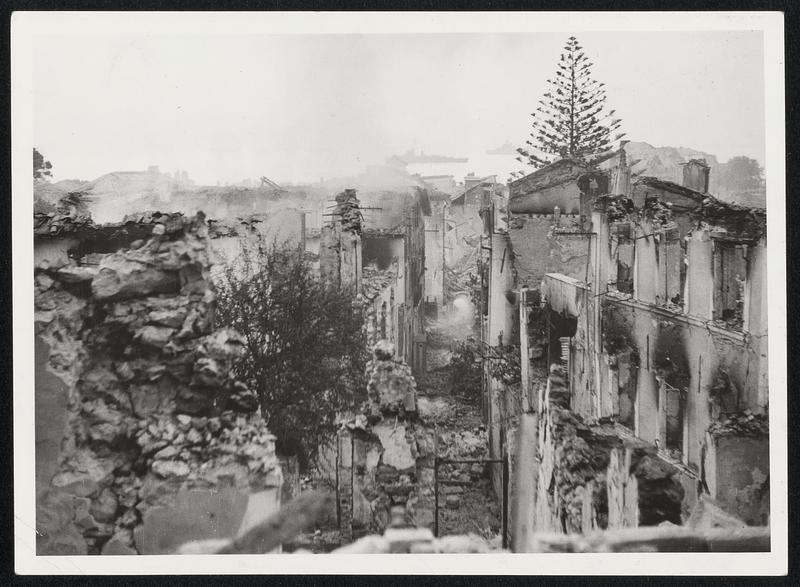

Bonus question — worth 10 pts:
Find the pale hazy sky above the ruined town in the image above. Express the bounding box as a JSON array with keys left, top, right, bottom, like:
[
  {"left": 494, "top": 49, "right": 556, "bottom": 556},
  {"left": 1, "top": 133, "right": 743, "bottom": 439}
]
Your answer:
[{"left": 34, "top": 32, "right": 765, "bottom": 184}]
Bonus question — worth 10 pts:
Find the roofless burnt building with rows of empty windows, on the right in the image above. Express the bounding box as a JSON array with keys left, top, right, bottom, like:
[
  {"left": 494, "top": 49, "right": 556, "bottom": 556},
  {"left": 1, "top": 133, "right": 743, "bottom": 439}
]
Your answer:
[{"left": 484, "top": 147, "right": 769, "bottom": 548}]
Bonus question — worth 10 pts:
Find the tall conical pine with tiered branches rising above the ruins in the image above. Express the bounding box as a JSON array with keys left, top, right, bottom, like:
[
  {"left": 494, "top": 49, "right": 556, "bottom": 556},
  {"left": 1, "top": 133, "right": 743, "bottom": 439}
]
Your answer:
[{"left": 517, "top": 37, "right": 625, "bottom": 168}]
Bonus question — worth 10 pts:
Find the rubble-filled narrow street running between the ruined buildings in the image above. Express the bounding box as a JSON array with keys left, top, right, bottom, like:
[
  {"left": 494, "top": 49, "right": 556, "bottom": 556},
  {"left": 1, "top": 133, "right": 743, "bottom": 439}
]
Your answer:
[{"left": 418, "top": 300, "right": 500, "bottom": 542}]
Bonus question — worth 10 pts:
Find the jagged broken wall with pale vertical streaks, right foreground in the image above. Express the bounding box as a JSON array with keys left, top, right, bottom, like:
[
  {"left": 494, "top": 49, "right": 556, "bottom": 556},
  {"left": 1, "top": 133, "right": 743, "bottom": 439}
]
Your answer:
[{"left": 518, "top": 366, "right": 687, "bottom": 540}]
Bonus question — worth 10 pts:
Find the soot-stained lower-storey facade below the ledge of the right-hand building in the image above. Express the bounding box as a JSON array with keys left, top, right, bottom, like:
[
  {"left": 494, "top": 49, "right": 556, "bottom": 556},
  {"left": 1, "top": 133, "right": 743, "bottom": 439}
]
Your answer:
[{"left": 598, "top": 296, "right": 767, "bottom": 471}]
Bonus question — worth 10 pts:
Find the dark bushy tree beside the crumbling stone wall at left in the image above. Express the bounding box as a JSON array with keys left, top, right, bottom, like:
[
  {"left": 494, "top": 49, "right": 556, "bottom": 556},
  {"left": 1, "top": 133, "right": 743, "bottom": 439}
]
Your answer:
[{"left": 217, "top": 242, "right": 367, "bottom": 462}]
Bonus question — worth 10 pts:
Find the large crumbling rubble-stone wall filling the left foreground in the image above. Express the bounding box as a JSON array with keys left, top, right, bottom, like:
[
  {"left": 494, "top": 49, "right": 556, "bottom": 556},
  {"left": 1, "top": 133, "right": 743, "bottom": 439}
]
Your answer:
[{"left": 35, "top": 214, "right": 281, "bottom": 554}]
